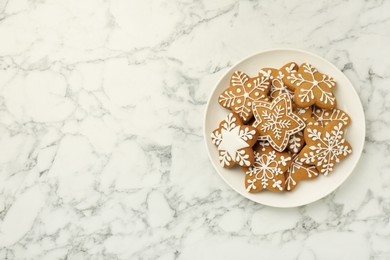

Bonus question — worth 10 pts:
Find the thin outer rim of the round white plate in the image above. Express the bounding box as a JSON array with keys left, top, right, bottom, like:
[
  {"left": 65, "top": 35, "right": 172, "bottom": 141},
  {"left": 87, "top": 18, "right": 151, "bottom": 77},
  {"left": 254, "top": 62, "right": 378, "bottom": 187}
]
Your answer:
[{"left": 203, "top": 48, "right": 366, "bottom": 208}]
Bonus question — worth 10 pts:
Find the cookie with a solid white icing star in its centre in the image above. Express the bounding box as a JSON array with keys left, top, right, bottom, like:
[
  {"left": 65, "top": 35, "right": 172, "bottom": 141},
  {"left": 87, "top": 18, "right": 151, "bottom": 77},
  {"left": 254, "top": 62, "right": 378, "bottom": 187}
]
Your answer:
[{"left": 211, "top": 113, "right": 258, "bottom": 168}]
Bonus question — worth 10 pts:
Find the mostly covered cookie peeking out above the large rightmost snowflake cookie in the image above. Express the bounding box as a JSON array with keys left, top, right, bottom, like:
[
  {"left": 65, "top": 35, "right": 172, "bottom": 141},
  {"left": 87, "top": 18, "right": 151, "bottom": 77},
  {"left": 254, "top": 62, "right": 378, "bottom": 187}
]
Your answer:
[{"left": 312, "top": 107, "right": 351, "bottom": 126}]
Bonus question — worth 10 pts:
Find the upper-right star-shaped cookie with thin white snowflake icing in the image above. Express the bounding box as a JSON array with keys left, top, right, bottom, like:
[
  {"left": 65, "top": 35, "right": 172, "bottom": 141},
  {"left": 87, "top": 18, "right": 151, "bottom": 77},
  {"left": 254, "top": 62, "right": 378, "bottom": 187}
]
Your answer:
[{"left": 283, "top": 63, "right": 336, "bottom": 108}]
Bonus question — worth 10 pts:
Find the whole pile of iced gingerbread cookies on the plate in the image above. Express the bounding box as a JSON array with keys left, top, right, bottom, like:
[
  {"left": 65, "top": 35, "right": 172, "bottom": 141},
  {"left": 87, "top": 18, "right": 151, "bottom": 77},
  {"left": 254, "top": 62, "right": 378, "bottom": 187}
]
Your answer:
[{"left": 211, "top": 62, "right": 352, "bottom": 192}]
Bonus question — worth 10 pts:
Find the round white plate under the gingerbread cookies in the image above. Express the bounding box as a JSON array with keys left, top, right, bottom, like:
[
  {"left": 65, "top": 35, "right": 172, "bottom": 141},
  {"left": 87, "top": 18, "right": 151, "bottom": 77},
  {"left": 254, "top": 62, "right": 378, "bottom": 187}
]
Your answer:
[{"left": 204, "top": 49, "right": 366, "bottom": 208}]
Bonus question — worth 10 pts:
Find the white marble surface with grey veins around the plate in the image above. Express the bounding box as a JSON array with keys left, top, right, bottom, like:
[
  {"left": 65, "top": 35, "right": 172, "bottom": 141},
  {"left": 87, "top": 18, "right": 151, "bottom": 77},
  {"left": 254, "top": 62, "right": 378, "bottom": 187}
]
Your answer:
[{"left": 0, "top": 0, "right": 390, "bottom": 260}]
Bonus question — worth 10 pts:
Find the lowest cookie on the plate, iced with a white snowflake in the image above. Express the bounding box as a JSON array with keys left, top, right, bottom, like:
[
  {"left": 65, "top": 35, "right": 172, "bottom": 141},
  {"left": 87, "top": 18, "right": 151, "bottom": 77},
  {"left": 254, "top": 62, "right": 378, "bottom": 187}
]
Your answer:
[{"left": 243, "top": 147, "right": 292, "bottom": 192}]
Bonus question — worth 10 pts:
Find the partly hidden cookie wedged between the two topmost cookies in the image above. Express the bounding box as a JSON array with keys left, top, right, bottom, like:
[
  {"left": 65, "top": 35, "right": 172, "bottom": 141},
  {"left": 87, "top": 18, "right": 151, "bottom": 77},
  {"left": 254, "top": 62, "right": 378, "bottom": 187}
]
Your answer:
[{"left": 259, "top": 62, "right": 298, "bottom": 99}]
